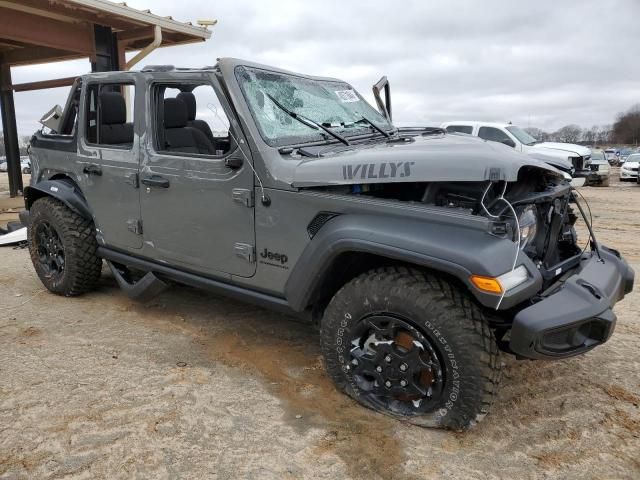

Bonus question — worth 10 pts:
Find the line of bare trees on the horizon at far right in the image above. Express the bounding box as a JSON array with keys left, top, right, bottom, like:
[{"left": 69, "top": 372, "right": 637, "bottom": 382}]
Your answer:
[{"left": 525, "top": 103, "right": 640, "bottom": 145}]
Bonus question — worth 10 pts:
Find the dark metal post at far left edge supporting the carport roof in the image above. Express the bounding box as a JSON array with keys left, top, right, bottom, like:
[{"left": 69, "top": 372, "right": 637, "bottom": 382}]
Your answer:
[{"left": 0, "top": 59, "right": 23, "bottom": 197}]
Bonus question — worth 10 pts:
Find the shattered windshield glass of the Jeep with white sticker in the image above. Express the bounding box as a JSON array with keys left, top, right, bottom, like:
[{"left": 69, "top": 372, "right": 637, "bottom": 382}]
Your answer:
[{"left": 236, "top": 67, "right": 393, "bottom": 146}]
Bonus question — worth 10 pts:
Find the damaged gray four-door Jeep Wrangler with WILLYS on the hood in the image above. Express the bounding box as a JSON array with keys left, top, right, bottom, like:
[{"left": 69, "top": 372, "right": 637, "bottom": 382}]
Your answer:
[{"left": 22, "top": 58, "right": 634, "bottom": 429}]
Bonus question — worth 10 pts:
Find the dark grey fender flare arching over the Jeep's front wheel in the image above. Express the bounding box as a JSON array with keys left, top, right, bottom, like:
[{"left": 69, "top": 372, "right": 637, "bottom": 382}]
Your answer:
[{"left": 285, "top": 214, "right": 542, "bottom": 311}]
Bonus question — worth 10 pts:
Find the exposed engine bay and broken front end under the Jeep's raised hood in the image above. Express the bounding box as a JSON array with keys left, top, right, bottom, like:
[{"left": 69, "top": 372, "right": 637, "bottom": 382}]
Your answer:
[{"left": 314, "top": 168, "right": 587, "bottom": 282}]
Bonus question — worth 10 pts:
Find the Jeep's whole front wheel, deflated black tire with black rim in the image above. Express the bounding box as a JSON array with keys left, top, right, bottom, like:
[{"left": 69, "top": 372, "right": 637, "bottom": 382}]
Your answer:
[{"left": 321, "top": 267, "right": 500, "bottom": 430}]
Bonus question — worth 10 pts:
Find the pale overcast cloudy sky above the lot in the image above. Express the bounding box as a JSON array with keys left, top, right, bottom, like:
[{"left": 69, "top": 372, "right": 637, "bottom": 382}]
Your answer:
[{"left": 6, "top": 0, "right": 640, "bottom": 134}]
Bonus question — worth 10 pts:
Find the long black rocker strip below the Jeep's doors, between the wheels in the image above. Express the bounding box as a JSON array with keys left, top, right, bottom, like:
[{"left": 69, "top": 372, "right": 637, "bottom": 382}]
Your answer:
[{"left": 98, "top": 247, "right": 310, "bottom": 320}]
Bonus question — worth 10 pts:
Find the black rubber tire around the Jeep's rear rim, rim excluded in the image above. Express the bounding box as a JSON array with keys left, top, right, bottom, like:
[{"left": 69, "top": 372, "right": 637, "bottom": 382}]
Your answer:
[{"left": 27, "top": 197, "right": 102, "bottom": 297}]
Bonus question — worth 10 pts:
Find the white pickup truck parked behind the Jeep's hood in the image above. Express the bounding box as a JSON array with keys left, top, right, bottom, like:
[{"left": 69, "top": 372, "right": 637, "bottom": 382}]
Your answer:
[{"left": 440, "top": 120, "right": 591, "bottom": 182}]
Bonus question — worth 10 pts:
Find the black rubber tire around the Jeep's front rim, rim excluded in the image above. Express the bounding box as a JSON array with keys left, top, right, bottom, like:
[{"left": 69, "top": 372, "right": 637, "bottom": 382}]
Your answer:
[{"left": 320, "top": 267, "right": 501, "bottom": 430}]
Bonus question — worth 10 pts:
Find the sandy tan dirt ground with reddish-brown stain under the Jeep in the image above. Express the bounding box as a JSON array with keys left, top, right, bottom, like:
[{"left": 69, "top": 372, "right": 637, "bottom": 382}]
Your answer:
[{"left": 0, "top": 171, "right": 640, "bottom": 480}]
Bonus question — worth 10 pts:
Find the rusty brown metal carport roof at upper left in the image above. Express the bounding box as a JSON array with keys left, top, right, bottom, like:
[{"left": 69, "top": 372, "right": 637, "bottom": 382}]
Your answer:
[{"left": 0, "top": 0, "right": 214, "bottom": 65}]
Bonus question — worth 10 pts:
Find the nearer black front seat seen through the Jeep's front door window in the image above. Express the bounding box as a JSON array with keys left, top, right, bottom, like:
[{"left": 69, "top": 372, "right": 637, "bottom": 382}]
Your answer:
[{"left": 164, "top": 98, "right": 215, "bottom": 155}]
